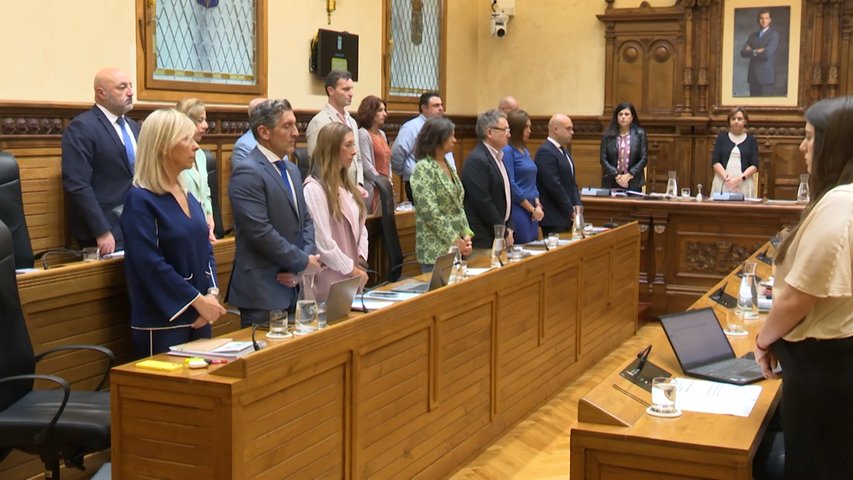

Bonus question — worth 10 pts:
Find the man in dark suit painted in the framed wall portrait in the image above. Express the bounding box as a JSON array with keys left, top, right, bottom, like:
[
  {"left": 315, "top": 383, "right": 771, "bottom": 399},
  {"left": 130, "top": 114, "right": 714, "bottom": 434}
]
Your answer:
[{"left": 740, "top": 10, "right": 779, "bottom": 97}]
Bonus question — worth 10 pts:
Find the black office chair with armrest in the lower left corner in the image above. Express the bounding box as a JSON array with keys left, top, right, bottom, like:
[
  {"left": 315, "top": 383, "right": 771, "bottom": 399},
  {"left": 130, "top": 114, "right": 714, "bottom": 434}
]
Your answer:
[{"left": 0, "top": 222, "right": 115, "bottom": 479}]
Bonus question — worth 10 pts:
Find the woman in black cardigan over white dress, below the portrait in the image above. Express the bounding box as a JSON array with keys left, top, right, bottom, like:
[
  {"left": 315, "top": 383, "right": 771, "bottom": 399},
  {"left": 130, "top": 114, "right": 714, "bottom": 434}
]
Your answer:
[{"left": 711, "top": 107, "right": 758, "bottom": 198}]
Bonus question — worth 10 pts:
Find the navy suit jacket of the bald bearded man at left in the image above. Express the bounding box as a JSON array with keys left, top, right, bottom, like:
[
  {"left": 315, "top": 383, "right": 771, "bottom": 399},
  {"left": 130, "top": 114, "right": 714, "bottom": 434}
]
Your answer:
[{"left": 62, "top": 105, "right": 139, "bottom": 249}]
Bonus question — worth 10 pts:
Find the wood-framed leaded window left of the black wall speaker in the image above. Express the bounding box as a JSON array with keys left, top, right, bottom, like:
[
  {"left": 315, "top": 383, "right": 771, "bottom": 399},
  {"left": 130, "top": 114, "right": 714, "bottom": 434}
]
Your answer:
[{"left": 137, "top": 0, "right": 266, "bottom": 102}]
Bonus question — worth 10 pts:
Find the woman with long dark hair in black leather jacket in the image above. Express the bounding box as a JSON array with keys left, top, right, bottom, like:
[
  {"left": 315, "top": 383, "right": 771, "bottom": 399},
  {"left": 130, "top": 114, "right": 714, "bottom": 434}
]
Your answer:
[{"left": 601, "top": 102, "right": 649, "bottom": 191}]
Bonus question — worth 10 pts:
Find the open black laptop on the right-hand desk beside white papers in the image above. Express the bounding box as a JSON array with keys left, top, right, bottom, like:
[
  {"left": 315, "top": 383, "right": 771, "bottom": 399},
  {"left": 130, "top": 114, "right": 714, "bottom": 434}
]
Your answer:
[{"left": 660, "top": 307, "right": 764, "bottom": 385}]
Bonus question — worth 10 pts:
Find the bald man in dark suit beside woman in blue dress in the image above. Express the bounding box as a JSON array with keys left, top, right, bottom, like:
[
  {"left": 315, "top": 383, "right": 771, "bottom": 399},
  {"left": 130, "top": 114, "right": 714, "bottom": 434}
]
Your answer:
[{"left": 533, "top": 113, "right": 582, "bottom": 237}]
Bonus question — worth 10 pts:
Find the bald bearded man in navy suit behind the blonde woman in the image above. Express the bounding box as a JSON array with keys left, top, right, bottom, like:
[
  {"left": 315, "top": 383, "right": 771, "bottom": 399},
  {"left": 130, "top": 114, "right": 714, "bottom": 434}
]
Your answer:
[{"left": 62, "top": 68, "right": 139, "bottom": 255}]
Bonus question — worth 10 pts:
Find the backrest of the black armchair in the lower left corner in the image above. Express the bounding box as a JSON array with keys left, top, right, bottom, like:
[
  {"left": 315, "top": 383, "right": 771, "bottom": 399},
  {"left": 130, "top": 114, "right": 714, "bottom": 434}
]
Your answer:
[{"left": 0, "top": 221, "right": 35, "bottom": 410}]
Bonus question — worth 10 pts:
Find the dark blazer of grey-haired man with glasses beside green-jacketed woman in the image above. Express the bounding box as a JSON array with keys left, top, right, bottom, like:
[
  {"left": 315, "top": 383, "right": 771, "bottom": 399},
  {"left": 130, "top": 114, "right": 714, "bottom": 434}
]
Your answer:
[{"left": 460, "top": 142, "right": 509, "bottom": 248}]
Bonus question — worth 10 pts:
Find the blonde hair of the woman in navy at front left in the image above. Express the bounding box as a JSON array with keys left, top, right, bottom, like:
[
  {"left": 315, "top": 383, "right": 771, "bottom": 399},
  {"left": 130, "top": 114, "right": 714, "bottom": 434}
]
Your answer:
[{"left": 133, "top": 108, "right": 196, "bottom": 195}]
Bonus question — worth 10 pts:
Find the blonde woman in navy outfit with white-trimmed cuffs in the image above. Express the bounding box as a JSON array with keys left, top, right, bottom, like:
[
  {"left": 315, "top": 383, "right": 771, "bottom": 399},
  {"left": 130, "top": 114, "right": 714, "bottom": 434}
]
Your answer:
[{"left": 121, "top": 109, "right": 225, "bottom": 357}]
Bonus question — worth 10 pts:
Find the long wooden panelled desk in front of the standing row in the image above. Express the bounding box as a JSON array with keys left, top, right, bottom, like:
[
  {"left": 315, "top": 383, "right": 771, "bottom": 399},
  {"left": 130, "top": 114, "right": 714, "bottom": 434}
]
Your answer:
[{"left": 111, "top": 224, "right": 639, "bottom": 479}]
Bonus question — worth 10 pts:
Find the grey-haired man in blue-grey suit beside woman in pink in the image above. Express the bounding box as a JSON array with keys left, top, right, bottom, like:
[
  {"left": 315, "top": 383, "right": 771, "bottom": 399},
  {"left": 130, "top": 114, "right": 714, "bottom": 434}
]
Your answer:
[{"left": 226, "top": 100, "right": 320, "bottom": 327}]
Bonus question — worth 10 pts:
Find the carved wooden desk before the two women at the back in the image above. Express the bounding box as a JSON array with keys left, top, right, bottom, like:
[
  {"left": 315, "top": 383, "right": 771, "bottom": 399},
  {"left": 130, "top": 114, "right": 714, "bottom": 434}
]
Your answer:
[{"left": 583, "top": 197, "right": 803, "bottom": 314}]
